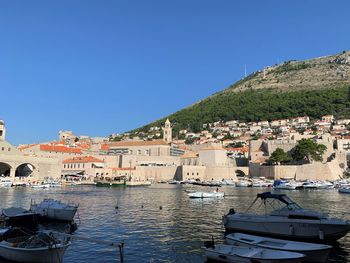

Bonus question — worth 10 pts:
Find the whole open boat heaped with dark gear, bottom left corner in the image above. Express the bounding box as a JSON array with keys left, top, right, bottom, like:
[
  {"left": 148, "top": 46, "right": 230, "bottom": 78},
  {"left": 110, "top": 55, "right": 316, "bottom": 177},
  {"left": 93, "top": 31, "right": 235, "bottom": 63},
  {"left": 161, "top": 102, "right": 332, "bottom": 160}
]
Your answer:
[{"left": 0, "top": 232, "right": 71, "bottom": 263}]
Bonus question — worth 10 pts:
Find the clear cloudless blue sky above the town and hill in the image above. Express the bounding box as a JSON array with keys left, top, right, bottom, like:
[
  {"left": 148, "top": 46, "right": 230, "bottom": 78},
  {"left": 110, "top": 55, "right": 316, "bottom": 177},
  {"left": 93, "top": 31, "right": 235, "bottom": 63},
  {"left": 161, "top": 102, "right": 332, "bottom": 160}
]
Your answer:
[{"left": 0, "top": 0, "right": 350, "bottom": 144}]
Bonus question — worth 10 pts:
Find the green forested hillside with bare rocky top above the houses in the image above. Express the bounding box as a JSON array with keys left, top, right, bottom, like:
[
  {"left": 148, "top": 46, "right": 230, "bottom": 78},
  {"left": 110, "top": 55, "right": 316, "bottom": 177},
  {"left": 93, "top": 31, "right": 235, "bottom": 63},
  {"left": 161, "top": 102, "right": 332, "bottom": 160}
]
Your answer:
[{"left": 133, "top": 51, "right": 350, "bottom": 134}]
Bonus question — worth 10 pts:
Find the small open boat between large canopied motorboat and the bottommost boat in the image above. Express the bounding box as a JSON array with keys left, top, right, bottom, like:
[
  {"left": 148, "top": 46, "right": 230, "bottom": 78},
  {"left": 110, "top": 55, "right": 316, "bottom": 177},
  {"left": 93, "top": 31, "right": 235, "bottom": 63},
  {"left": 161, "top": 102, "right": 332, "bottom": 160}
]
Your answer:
[{"left": 225, "top": 233, "right": 332, "bottom": 263}]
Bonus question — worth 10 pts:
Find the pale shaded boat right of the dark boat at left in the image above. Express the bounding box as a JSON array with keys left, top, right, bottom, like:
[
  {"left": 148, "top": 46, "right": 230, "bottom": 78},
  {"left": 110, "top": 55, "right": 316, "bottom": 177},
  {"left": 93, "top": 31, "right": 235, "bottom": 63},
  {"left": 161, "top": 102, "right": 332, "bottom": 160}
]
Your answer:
[{"left": 30, "top": 199, "right": 78, "bottom": 221}]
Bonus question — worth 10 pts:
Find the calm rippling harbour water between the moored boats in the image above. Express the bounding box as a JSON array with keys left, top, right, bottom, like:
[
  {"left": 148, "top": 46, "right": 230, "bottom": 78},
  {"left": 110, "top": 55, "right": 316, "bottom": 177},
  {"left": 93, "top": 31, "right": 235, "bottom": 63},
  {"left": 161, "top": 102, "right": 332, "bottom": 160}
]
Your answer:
[{"left": 0, "top": 185, "right": 350, "bottom": 263}]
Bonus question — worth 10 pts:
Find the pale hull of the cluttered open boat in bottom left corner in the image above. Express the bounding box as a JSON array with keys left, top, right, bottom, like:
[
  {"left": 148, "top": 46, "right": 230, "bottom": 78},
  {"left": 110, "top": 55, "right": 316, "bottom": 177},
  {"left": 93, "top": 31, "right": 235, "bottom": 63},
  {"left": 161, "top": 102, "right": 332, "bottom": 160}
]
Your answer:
[{"left": 0, "top": 241, "right": 70, "bottom": 263}]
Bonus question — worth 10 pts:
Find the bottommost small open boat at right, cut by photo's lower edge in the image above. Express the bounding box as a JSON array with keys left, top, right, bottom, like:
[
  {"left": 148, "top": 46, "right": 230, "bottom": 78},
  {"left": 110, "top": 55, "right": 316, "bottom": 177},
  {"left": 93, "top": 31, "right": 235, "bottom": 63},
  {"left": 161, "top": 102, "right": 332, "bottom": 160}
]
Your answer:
[{"left": 206, "top": 244, "right": 305, "bottom": 263}]
